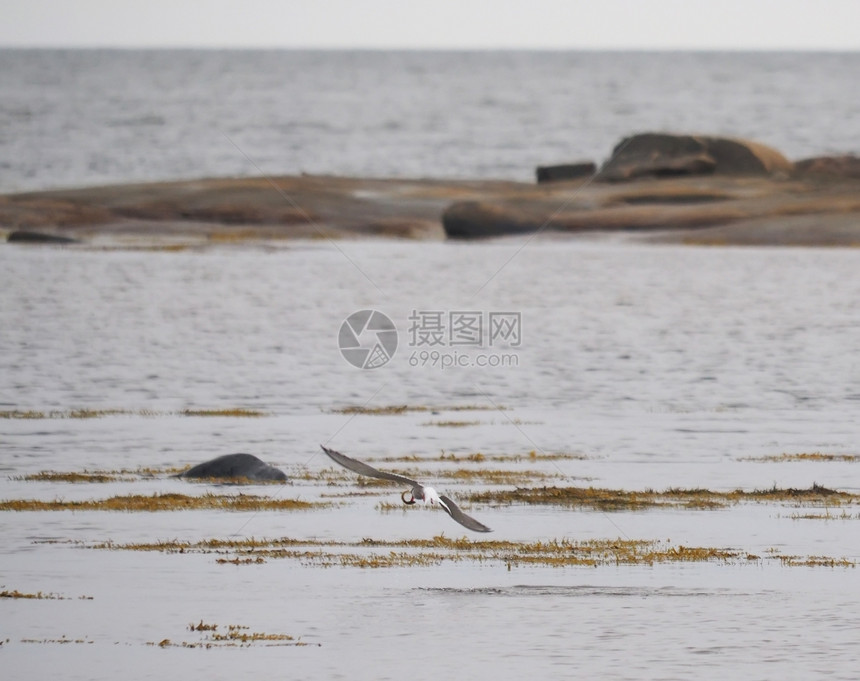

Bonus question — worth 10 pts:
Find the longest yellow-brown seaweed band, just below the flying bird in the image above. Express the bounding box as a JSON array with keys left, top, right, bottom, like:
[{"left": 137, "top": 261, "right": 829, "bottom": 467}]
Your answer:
[{"left": 88, "top": 535, "right": 855, "bottom": 570}]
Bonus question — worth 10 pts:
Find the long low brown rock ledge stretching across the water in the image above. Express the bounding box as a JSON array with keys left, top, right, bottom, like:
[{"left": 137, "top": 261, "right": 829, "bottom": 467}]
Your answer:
[{"left": 0, "top": 170, "right": 860, "bottom": 246}]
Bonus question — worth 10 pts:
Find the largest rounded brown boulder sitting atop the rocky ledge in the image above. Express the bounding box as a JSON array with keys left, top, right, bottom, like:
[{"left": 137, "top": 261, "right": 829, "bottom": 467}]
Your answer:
[{"left": 597, "top": 133, "right": 794, "bottom": 182}]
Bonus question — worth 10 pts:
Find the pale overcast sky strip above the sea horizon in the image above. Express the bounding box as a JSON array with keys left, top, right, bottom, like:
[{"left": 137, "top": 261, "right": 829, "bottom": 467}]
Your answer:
[{"left": 0, "top": 0, "right": 860, "bottom": 50}]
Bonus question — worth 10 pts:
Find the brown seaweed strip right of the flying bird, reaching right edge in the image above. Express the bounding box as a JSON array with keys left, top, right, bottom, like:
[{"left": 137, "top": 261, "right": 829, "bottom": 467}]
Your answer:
[{"left": 468, "top": 484, "right": 860, "bottom": 511}]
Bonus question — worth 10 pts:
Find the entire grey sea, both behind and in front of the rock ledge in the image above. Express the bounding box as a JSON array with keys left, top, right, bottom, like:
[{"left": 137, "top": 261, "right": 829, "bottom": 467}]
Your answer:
[{"left": 0, "top": 52, "right": 860, "bottom": 681}]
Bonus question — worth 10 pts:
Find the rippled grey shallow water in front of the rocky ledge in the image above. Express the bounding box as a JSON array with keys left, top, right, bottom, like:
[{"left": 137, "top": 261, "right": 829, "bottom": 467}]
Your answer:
[{"left": 0, "top": 238, "right": 860, "bottom": 679}]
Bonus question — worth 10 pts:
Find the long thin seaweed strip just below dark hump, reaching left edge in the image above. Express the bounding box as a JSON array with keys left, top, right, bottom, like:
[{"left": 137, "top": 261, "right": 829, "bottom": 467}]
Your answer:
[{"left": 0, "top": 493, "right": 322, "bottom": 512}]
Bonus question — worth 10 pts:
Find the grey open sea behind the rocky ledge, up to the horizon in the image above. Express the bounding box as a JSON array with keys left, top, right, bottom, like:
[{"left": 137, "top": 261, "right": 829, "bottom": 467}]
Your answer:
[{"left": 0, "top": 50, "right": 860, "bottom": 192}]
